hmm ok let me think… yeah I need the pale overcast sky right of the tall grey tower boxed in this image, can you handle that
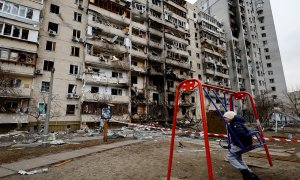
[187,0,300,90]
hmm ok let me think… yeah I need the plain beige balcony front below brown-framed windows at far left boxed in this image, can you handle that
[0,62,34,76]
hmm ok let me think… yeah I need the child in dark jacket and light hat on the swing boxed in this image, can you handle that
[223,111,259,180]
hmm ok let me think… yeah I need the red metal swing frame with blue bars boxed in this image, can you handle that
[167,79,272,180]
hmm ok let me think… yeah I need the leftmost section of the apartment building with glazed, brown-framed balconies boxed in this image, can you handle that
[0,0,43,132]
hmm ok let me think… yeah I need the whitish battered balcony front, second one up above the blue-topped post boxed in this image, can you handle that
[85,74,129,86]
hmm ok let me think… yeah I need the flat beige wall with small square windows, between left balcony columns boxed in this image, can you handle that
[31,0,87,125]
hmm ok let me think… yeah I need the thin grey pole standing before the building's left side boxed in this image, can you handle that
[43,68,55,146]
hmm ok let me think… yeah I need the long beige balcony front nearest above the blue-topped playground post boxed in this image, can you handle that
[83,93,129,103]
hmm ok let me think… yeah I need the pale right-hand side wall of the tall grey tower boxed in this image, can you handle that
[252,0,287,100]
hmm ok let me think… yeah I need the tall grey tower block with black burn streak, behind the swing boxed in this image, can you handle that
[195,0,286,101]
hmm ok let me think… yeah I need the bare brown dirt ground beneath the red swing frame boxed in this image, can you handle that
[4,138,300,180]
